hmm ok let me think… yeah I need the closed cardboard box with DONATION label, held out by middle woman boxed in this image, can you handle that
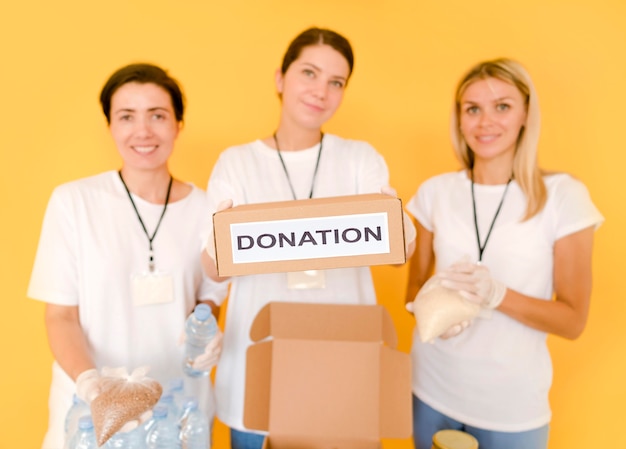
[213,194,406,276]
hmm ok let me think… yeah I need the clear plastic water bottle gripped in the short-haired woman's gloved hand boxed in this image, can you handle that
[183,304,217,377]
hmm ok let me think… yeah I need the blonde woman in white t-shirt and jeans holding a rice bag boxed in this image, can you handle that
[406,59,603,449]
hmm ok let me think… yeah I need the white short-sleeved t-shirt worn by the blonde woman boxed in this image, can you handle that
[407,171,603,432]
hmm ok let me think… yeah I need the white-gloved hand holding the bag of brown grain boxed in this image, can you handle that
[76,367,152,432]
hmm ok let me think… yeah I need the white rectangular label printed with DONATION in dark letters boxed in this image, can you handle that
[230,212,390,263]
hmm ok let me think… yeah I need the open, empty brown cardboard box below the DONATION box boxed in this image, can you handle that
[244,302,412,449]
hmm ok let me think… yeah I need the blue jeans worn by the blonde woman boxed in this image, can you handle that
[413,395,550,449]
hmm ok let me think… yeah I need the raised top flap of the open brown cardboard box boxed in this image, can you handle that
[250,302,398,348]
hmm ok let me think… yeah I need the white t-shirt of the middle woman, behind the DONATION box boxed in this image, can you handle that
[207,134,389,431]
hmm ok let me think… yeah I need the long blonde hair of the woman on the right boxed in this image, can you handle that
[450,58,547,220]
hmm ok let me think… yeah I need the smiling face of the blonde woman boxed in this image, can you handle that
[459,77,526,164]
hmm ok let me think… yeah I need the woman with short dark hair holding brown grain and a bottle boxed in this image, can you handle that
[28,64,219,449]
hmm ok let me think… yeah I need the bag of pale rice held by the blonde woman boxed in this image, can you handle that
[413,275,481,342]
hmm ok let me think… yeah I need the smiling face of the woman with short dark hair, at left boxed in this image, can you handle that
[109,82,180,171]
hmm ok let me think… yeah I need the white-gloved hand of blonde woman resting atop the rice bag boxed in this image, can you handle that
[437,260,506,309]
